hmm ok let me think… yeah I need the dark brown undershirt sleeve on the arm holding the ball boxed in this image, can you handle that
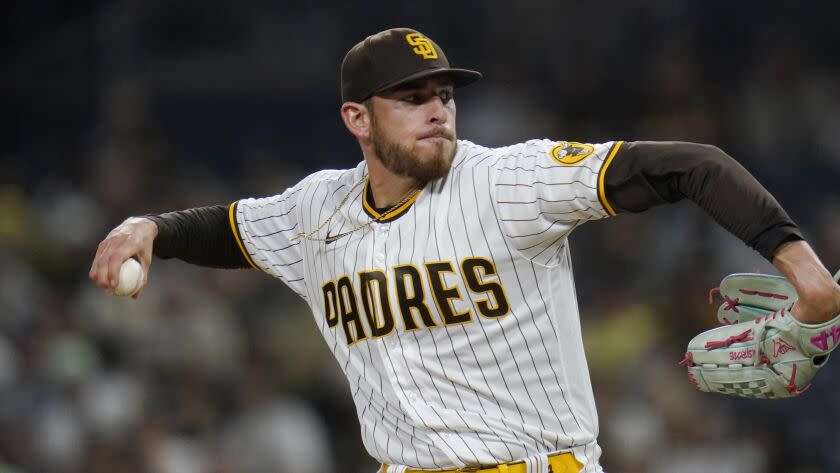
[146,205,250,268]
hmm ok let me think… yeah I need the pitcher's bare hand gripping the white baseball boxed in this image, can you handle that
[89,217,158,299]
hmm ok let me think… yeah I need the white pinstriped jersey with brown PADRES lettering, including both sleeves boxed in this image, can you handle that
[231,140,621,472]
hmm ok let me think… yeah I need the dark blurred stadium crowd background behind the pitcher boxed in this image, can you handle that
[0,0,840,473]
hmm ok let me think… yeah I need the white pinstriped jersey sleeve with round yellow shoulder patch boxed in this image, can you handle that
[494,140,622,265]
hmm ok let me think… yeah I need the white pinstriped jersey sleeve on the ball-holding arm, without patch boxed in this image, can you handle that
[229,182,306,299]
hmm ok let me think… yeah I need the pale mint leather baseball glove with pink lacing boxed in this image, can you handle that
[680,272,840,399]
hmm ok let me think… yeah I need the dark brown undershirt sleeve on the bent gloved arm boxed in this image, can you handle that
[604,141,804,262]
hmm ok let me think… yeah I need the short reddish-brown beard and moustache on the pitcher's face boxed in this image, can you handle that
[371,114,456,184]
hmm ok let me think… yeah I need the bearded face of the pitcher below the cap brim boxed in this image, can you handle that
[368,77,456,184]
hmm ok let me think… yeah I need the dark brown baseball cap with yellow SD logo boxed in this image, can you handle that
[341,28,481,102]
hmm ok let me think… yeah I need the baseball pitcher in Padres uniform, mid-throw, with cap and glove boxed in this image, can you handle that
[90,28,840,473]
